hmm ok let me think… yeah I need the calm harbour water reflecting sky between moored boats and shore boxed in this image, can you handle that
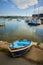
[0,19,43,42]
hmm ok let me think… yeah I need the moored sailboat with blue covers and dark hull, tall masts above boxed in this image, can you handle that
[27,2,41,26]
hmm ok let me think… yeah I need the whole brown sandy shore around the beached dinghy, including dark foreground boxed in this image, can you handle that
[0,41,43,65]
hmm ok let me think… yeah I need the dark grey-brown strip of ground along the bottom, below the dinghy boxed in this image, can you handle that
[0,52,43,65]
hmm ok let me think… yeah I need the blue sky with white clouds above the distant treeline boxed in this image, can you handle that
[0,0,43,16]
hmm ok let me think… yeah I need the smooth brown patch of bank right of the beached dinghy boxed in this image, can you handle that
[24,46,43,62]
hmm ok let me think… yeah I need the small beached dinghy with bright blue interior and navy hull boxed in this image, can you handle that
[9,39,31,57]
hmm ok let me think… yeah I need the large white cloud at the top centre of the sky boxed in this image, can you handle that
[11,0,38,9]
